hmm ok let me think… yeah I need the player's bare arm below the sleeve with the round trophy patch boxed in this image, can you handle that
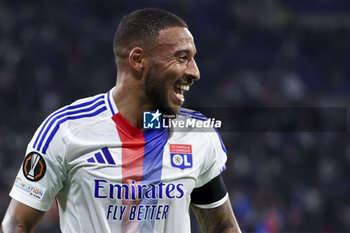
[0,199,45,233]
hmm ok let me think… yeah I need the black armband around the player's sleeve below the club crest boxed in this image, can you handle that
[191,174,227,205]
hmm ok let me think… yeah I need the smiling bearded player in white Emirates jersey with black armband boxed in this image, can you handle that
[0,9,240,233]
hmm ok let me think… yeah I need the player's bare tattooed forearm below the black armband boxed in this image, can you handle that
[191,199,241,233]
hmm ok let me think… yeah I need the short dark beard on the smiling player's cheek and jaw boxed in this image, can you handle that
[145,68,178,115]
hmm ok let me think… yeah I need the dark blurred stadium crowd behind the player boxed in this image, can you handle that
[0,0,350,233]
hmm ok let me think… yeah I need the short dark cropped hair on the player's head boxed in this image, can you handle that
[113,8,188,58]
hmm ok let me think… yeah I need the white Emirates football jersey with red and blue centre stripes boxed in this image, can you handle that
[10,91,227,233]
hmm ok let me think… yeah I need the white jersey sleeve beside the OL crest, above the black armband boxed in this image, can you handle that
[196,128,227,188]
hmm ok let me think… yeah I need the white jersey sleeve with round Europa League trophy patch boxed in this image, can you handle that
[10,118,66,211]
